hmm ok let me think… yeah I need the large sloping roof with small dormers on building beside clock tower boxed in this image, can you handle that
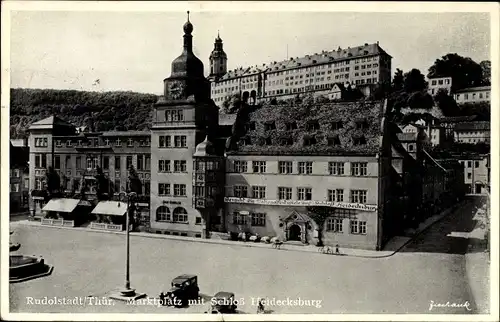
[226,101,384,155]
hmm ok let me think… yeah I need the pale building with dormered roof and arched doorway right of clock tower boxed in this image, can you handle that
[223,102,391,249]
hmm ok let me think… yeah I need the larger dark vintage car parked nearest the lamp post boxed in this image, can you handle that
[160,274,200,307]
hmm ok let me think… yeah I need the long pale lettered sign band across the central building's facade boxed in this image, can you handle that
[224,197,377,211]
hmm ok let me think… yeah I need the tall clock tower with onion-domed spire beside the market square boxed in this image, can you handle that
[150,11,219,237]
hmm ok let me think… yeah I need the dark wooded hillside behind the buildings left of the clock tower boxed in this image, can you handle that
[10,88,158,138]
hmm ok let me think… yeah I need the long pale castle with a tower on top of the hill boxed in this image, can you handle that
[209,36,392,106]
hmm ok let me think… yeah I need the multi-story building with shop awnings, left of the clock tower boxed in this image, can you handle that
[29,116,151,223]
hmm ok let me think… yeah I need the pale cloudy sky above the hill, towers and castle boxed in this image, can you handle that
[10,10,491,94]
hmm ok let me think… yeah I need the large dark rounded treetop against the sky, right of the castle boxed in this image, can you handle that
[427,54,483,92]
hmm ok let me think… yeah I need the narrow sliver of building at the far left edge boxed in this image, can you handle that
[9,140,29,213]
